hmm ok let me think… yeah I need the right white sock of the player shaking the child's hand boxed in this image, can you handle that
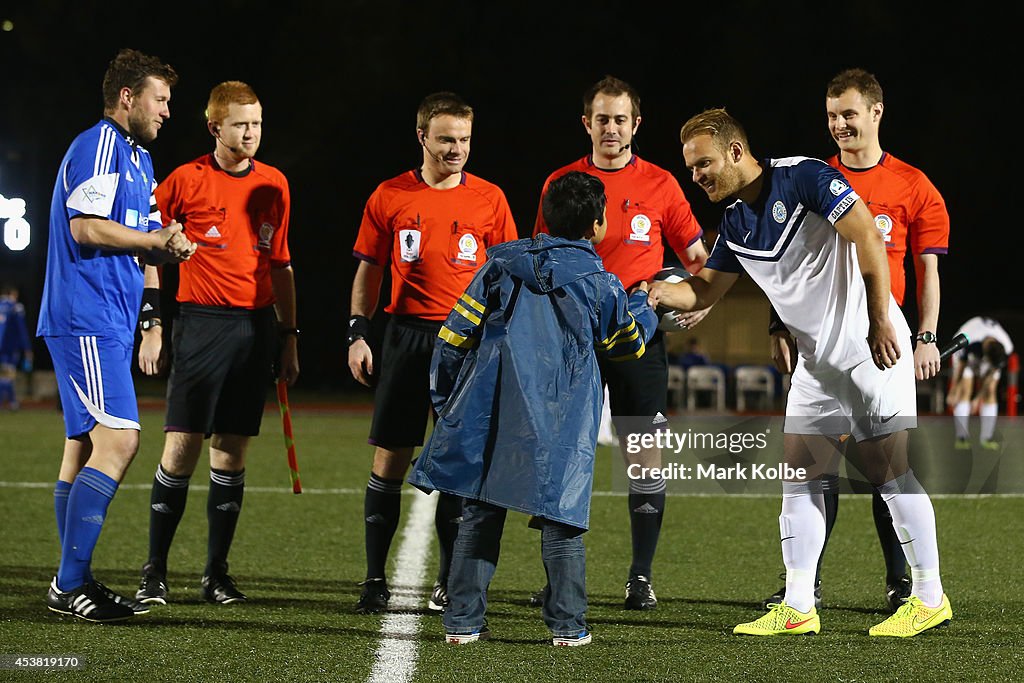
[879,470,942,607]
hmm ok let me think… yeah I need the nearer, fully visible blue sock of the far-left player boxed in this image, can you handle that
[57,467,118,591]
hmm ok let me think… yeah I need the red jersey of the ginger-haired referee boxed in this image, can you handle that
[156,155,291,308]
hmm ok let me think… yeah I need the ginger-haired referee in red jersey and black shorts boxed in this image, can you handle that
[135,81,299,604]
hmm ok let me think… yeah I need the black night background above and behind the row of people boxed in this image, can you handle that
[0,0,1024,390]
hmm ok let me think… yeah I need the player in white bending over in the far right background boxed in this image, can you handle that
[946,315,1014,451]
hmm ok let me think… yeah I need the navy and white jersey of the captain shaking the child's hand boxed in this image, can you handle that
[706,157,909,372]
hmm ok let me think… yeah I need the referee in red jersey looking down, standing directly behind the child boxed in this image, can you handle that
[530,76,708,609]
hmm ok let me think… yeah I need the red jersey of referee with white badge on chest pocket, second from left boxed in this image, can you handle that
[353,170,518,321]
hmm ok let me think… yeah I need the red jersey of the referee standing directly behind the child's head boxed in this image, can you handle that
[534,155,703,289]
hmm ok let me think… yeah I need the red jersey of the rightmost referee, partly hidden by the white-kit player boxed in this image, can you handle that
[828,153,949,306]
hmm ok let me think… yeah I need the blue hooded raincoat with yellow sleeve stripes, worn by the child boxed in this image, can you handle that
[409,234,657,528]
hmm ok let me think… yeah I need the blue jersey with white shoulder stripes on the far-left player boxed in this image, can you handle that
[36,119,162,339]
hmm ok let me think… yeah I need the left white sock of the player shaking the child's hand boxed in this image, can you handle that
[778,481,825,612]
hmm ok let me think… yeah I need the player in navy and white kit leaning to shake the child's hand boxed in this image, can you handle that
[651,109,952,637]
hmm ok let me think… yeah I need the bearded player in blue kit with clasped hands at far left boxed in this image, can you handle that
[37,49,196,622]
